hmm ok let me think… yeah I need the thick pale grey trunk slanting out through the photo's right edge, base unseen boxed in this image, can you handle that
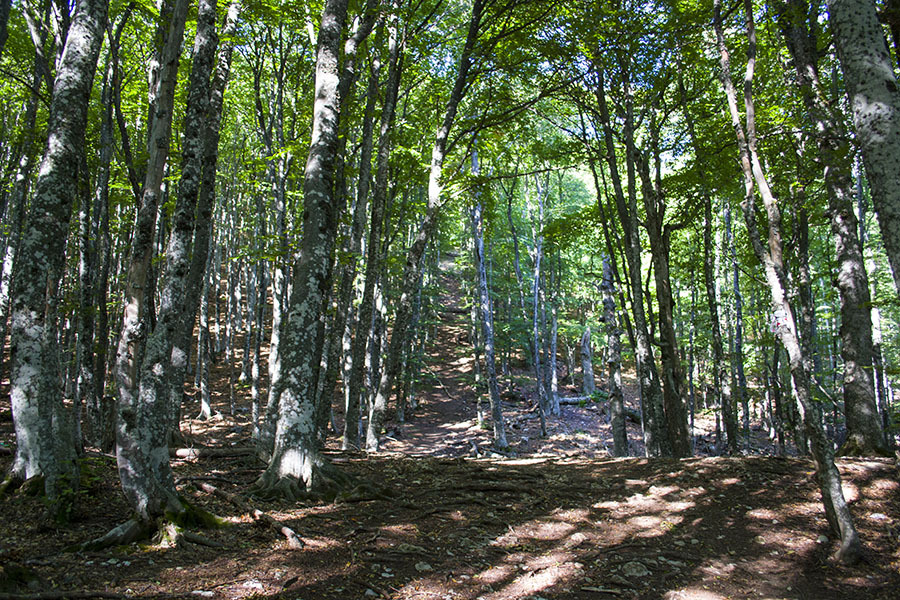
[827,0,900,294]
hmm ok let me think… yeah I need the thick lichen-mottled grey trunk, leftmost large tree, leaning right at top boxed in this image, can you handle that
[2,0,108,518]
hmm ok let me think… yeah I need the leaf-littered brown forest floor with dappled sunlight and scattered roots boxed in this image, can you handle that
[0,264,900,600]
